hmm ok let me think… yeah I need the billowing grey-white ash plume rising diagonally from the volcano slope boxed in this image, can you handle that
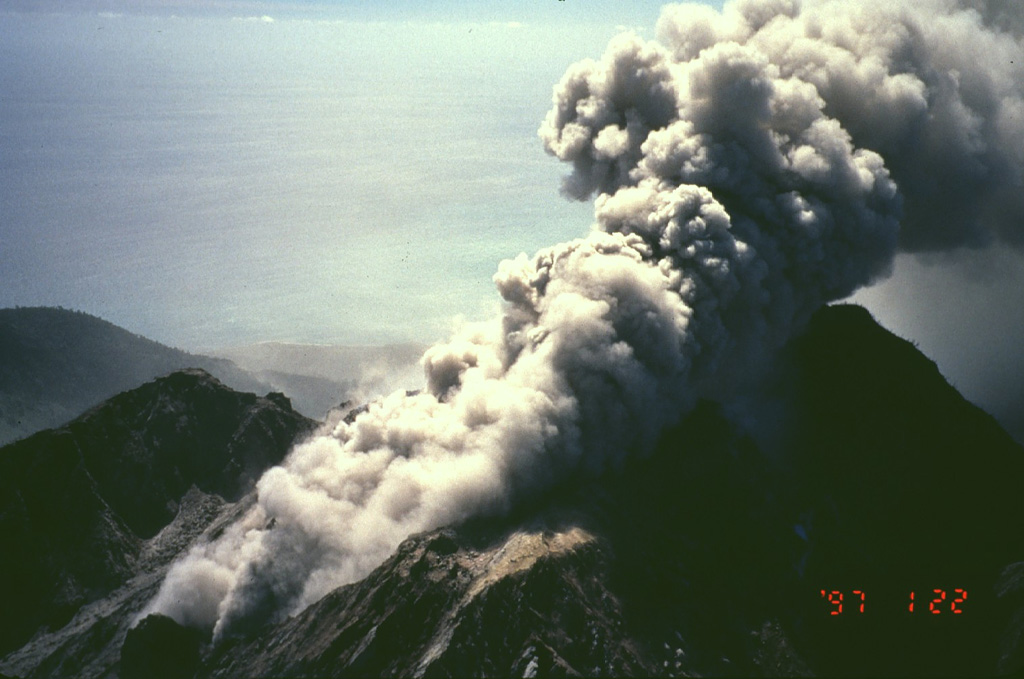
[150,0,1024,637]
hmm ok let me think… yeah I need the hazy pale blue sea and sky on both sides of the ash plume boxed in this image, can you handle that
[0,0,1024,440]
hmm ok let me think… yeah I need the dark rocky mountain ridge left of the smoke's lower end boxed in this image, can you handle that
[0,371,313,653]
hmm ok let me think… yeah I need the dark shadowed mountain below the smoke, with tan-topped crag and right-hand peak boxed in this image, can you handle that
[190,306,1024,677]
